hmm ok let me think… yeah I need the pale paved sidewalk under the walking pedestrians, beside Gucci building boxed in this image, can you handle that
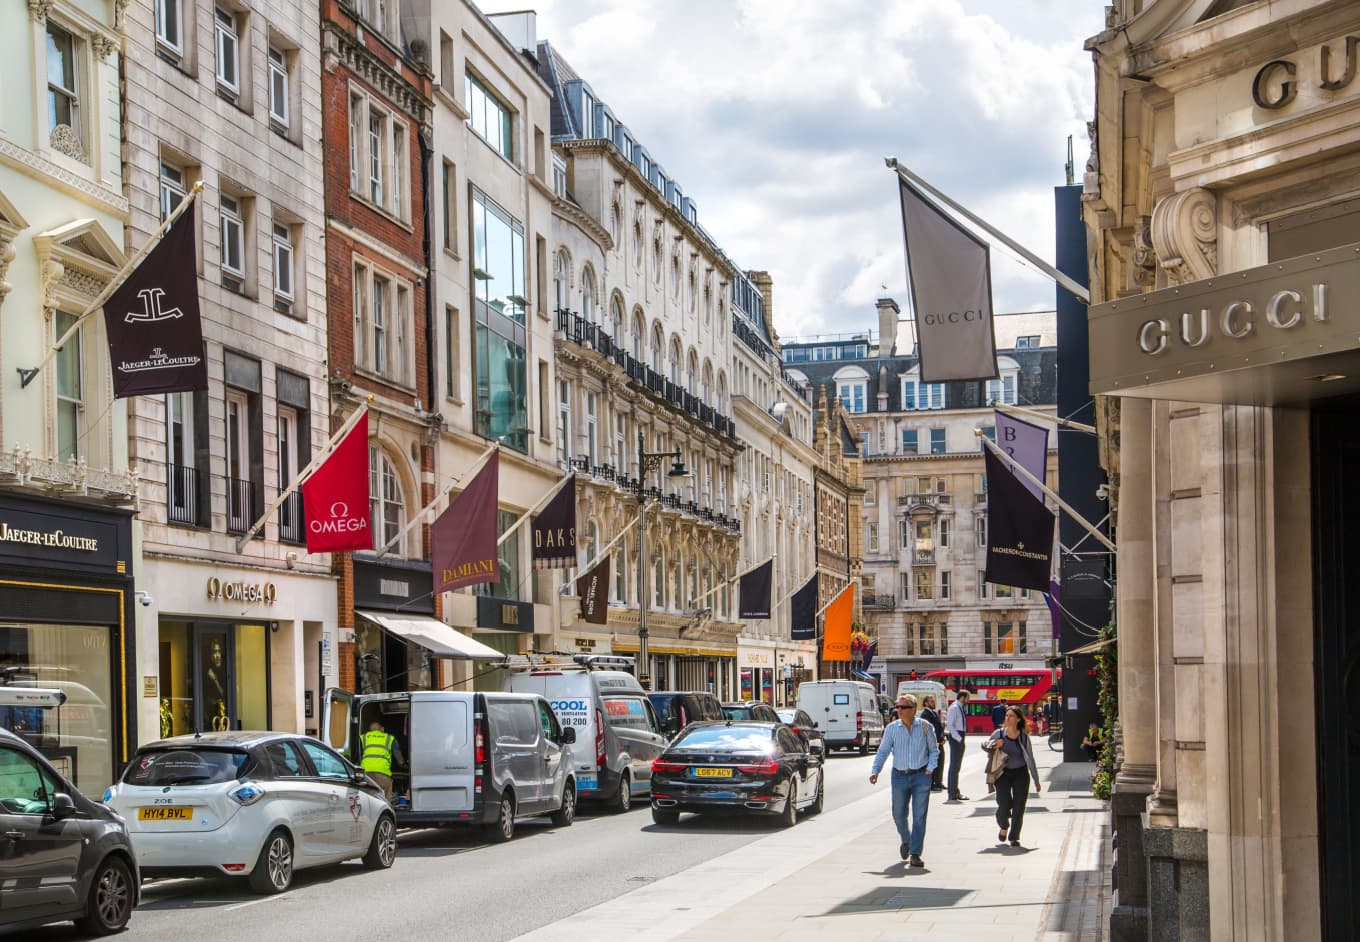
[520,737,1108,942]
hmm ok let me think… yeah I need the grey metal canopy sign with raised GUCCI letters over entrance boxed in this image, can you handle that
[1088,242,1360,405]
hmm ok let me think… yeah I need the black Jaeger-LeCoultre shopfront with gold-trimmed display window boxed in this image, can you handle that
[0,493,137,795]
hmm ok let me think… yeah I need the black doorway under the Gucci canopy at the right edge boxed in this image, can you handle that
[1312,398,1360,942]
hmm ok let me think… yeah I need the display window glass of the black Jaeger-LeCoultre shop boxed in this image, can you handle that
[0,623,117,795]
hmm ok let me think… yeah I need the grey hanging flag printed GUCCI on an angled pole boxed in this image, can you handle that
[899,177,997,383]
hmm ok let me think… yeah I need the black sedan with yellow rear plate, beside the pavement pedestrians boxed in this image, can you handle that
[651,720,826,828]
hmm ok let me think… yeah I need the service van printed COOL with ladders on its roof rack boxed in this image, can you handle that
[505,654,666,813]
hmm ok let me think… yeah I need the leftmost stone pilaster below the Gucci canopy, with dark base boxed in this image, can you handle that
[1110,398,1157,942]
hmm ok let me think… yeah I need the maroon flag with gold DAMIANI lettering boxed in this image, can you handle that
[430,451,500,593]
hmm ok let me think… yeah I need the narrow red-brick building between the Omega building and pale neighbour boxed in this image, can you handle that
[321,0,439,692]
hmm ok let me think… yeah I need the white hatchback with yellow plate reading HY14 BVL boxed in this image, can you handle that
[103,733,397,893]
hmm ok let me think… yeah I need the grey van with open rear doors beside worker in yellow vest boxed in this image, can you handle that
[322,688,577,841]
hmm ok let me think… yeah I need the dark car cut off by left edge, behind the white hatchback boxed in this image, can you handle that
[0,729,141,935]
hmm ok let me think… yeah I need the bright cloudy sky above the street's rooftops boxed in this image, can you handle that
[479,0,1104,340]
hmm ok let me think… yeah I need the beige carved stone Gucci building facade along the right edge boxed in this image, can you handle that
[1084,0,1360,939]
